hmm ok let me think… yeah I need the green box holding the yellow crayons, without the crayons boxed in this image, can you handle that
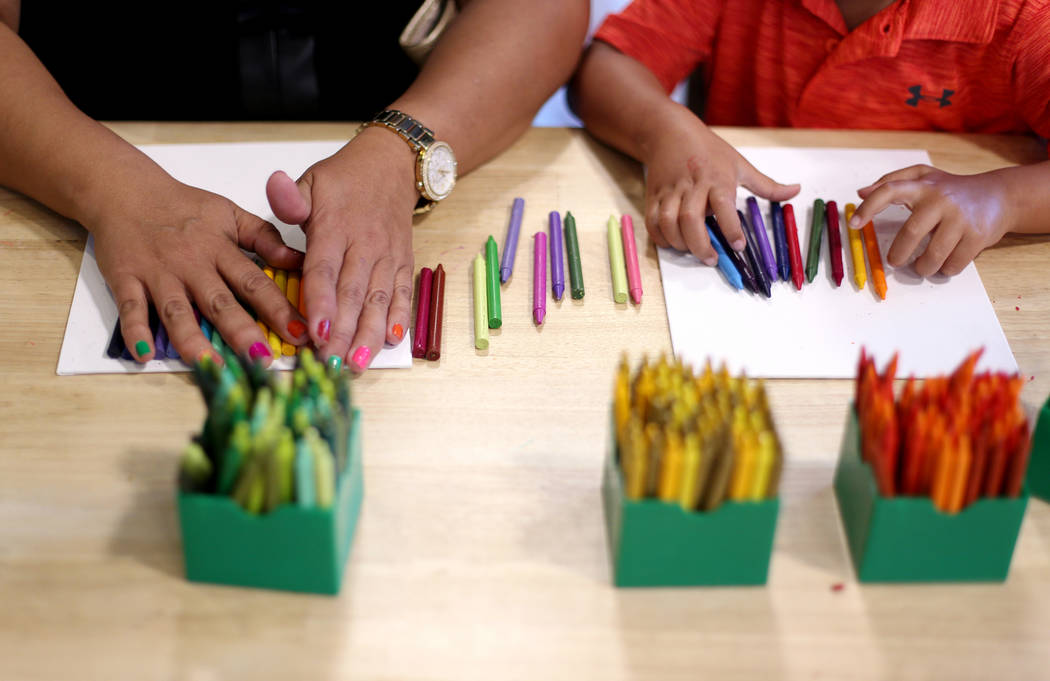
[602,419,780,587]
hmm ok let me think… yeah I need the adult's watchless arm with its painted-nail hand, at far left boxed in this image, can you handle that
[0,19,306,361]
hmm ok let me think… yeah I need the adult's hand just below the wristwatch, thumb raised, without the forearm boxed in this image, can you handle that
[267,128,419,371]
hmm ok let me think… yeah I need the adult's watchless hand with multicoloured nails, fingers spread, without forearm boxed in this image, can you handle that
[90,180,308,364]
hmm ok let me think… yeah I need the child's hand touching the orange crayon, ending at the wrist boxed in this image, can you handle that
[849,165,1013,277]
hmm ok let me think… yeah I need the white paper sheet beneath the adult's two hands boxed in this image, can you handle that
[58,142,412,376]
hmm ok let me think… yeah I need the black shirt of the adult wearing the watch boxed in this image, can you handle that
[19,0,419,121]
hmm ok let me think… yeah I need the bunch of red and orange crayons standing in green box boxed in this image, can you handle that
[856,350,1031,513]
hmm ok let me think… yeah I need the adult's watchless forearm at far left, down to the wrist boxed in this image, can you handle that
[0,24,170,227]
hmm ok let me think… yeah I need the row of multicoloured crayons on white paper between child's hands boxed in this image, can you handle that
[707,196,886,300]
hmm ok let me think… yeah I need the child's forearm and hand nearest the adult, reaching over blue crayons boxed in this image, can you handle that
[572,42,799,265]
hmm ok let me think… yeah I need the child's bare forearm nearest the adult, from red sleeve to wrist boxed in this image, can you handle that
[570,42,696,163]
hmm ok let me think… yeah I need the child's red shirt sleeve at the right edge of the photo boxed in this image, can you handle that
[1011,2,1050,151]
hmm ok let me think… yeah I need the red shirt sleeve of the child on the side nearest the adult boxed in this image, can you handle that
[594,0,725,93]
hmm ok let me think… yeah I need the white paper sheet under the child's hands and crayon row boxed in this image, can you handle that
[659,147,1017,378]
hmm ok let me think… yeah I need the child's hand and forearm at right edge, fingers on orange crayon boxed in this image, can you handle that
[849,162,1050,277]
